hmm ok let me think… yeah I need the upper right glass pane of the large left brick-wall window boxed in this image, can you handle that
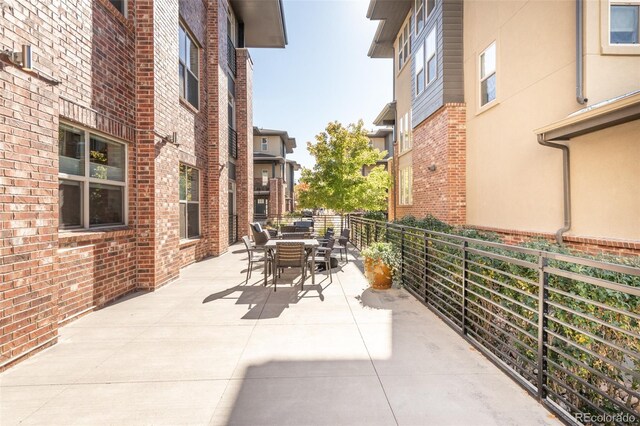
[89,135,126,182]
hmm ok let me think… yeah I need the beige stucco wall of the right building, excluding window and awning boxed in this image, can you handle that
[464,0,640,239]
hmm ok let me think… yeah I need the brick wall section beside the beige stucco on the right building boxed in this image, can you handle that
[394,104,466,224]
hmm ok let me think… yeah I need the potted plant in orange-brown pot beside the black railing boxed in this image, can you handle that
[362,243,400,290]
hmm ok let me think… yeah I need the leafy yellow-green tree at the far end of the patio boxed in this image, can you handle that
[298,120,391,214]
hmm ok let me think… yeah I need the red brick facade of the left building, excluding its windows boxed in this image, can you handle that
[0,0,253,370]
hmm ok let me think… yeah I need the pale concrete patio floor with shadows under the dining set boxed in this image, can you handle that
[0,245,560,425]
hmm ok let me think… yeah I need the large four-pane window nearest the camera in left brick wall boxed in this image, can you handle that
[58,125,127,229]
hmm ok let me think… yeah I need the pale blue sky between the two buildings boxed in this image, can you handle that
[251,0,393,167]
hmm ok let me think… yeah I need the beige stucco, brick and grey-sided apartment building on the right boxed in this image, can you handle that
[368,0,640,254]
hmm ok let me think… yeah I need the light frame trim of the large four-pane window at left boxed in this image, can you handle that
[58,120,129,232]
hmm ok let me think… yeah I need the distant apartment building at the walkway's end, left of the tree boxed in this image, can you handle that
[253,127,300,221]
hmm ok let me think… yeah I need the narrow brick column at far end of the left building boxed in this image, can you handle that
[236,49,253,237]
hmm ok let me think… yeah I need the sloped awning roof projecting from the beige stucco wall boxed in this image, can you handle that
[535,90,640,141]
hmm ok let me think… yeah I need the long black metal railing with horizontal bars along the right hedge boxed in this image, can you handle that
[349,216,640,425]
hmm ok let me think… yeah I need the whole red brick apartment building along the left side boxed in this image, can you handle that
[0,0,287,369]
